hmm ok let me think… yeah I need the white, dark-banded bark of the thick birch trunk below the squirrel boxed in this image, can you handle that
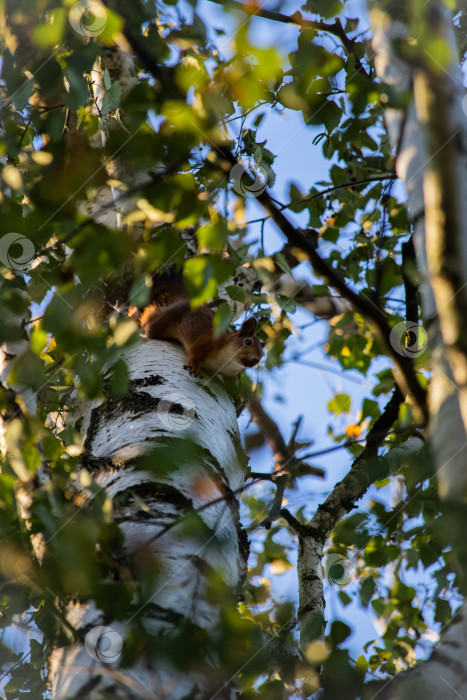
[50,340,247,700]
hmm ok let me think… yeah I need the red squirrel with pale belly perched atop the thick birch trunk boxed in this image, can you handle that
[140,276,263,377]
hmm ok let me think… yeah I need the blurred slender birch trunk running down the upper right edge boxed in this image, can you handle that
[371,2,467,499]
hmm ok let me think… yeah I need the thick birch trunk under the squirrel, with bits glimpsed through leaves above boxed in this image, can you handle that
[44,42,248,700]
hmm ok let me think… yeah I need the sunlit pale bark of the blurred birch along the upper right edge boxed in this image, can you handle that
[371,3,467,499]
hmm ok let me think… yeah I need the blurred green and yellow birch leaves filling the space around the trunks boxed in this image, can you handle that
[0,0,466,700]
